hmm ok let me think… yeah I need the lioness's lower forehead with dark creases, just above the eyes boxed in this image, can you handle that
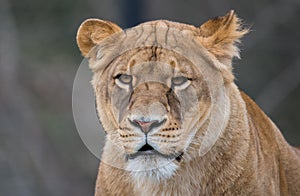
[114,47,196,79]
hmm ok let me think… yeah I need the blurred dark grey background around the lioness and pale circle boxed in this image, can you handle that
[0,0,300,196]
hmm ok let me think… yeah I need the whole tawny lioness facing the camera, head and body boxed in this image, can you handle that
[77,11,300,196]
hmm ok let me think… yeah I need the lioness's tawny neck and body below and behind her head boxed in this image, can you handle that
[96,86,300,196]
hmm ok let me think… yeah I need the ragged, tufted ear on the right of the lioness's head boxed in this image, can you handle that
[199,10,248,65]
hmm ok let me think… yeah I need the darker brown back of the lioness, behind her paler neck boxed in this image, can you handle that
[241,91,300,193]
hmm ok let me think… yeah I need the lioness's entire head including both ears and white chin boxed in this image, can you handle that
[77,12,247,180]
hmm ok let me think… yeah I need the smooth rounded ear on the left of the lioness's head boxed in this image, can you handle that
[76,19,122,57]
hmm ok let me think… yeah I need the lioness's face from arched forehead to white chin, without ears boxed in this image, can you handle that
[93,48,211,179]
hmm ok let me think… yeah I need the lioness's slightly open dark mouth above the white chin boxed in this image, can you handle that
[127,143,183,162]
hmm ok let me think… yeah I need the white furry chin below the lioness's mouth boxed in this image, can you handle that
[126,154,178,185]
